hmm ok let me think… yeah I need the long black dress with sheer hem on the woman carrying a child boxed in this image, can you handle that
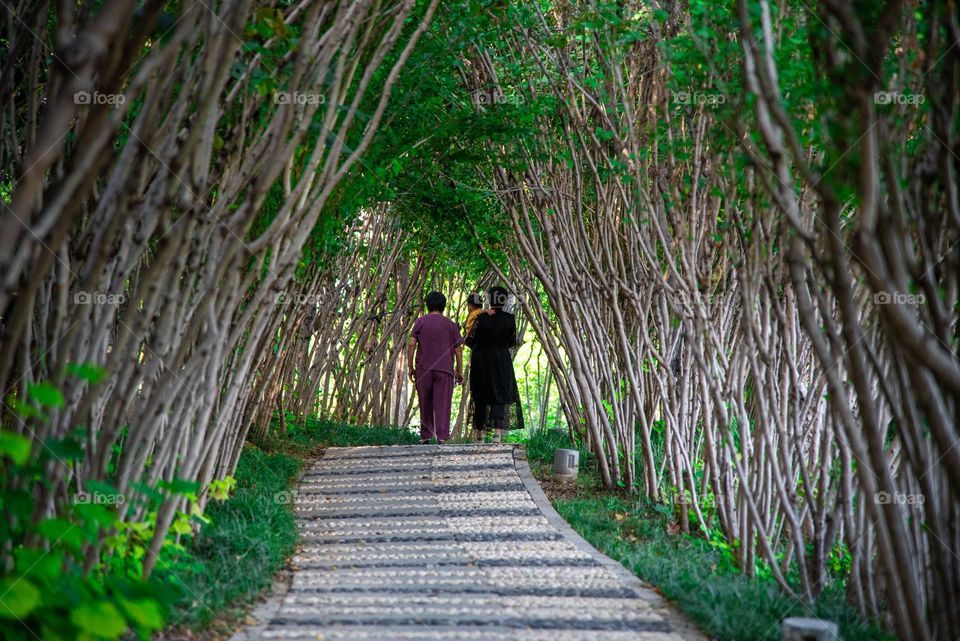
[466,310,523,430]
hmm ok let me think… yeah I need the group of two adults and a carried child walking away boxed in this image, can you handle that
[407,287,523,443]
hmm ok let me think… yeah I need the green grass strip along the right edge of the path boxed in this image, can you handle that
[527,433,893,641]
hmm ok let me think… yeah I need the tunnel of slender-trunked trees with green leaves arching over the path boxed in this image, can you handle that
[0,0,960,641]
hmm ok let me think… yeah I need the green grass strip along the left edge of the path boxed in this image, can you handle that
[159,419,417,641]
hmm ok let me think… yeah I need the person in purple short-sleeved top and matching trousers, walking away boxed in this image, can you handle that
[407,292,463,445]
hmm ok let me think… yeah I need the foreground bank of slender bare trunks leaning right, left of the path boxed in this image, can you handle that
[0,0,436,573]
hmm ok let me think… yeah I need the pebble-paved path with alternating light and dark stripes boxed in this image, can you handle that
[232,445,704,641]
